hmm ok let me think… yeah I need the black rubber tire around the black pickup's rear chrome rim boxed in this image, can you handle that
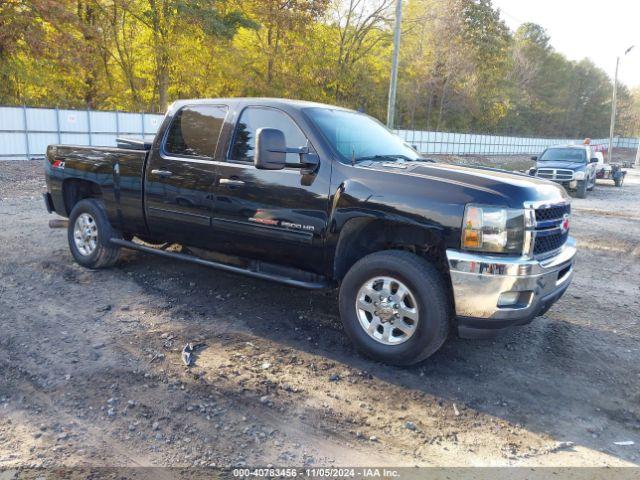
[67,199,121,269]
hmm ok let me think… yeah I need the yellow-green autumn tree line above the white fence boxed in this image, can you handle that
[0,0,640,137]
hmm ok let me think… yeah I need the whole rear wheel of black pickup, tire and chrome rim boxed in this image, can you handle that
[67,199,121,268]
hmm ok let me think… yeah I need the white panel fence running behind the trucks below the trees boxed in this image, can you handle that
[0,107,638,160]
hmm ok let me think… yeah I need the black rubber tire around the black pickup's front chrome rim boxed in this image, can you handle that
[340,250,450,365]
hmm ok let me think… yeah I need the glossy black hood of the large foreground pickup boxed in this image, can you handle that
[361,162,568,208]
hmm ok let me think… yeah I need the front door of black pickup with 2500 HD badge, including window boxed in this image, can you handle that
[212,106,331,273]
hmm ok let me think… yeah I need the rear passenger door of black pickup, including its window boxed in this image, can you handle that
[145,104,228,244]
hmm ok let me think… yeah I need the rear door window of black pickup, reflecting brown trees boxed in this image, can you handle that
[164,105,227,159]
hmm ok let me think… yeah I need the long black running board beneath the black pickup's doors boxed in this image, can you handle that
[111,238,330,290]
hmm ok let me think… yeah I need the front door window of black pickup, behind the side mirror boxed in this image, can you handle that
[230,107,307,163]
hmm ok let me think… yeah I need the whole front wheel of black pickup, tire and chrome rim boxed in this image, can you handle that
[340,250,450,365]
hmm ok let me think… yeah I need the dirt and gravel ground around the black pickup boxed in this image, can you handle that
[0,158,640,467]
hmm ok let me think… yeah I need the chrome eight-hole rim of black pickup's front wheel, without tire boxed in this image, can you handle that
[356,277,418,345]
